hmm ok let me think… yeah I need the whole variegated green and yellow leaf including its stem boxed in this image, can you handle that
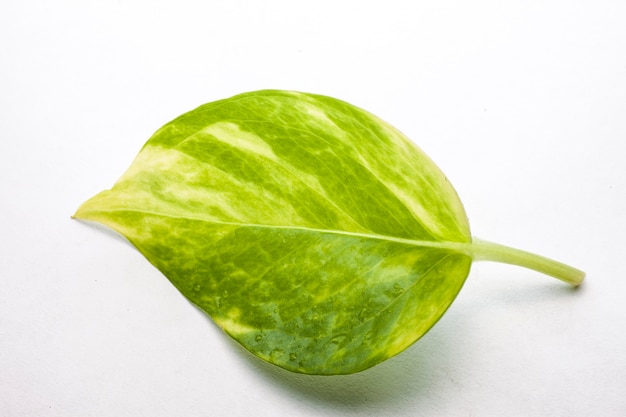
[74,91,584,374]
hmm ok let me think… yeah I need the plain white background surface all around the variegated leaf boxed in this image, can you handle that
[0,0,626,417]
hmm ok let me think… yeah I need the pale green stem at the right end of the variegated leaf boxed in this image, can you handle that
[471,238,585,286]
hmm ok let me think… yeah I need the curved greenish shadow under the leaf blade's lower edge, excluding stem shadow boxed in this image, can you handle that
[214,308,460,412]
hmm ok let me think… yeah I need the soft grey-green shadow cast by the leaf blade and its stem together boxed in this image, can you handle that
[212,274,584,413]
